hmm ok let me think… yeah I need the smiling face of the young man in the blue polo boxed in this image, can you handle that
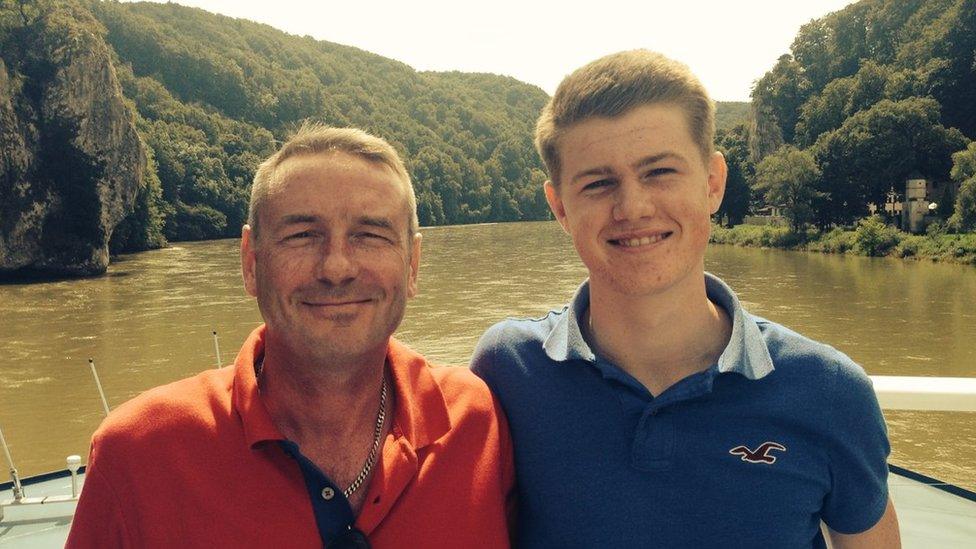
[546,104,726,297]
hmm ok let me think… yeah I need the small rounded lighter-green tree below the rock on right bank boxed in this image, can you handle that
[756,145,824,233]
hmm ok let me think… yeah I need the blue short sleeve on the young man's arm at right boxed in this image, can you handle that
[822,357,891,534]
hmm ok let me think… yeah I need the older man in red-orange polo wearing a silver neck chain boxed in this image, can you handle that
[68,127,513,547]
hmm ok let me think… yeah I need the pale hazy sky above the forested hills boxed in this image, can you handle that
[127,0,851,101]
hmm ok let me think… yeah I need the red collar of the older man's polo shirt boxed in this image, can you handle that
[231,325,451,449]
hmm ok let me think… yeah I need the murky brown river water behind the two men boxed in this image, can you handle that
[0,222,976,489]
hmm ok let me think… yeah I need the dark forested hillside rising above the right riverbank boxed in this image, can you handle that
[740,0,976,230]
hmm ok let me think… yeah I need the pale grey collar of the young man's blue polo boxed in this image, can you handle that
[542,273,773,380]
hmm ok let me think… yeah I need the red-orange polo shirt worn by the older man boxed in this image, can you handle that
[67,326,514,549]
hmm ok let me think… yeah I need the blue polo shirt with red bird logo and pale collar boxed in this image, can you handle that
[472,274,889,547]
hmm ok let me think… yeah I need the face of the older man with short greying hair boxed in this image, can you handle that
[242,152,420,361]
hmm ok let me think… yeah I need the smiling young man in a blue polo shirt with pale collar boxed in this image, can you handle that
[472,51,899,547]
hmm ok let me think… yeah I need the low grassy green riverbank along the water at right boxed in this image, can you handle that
[710,220,976,266]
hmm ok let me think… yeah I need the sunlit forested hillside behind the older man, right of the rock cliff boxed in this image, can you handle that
[87,2,560,248]
